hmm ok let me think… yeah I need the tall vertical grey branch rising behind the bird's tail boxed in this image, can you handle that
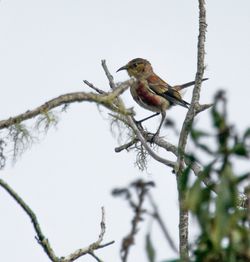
[176,0,207,261]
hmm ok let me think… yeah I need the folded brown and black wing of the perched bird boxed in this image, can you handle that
[147,75,189,108]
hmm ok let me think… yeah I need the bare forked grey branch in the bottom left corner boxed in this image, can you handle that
[0,179,114,262]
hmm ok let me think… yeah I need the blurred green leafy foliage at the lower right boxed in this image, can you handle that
[184,91,250,262]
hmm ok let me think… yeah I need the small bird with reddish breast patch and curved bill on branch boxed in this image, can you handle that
[117,58,208,136]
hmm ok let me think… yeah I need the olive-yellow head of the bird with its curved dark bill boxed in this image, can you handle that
[116,58,152,78]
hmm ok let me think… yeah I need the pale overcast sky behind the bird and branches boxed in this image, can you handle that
[0,0,250,262]
